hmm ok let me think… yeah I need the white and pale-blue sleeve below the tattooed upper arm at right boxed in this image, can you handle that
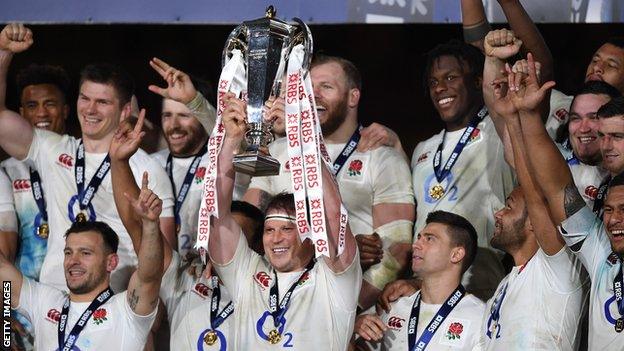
[559,206,611,280]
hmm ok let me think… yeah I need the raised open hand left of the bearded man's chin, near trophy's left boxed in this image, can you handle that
[108,109,145,161]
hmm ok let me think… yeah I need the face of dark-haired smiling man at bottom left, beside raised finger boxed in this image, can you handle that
[63,231,115,294]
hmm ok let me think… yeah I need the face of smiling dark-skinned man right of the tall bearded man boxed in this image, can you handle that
[428,56,481,130]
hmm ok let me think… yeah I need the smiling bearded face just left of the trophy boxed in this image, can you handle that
[162,99,208,157]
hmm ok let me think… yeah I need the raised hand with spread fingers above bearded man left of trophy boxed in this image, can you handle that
[147,57,197,104]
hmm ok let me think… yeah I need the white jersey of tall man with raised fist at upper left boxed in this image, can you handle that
[28,129,173,291]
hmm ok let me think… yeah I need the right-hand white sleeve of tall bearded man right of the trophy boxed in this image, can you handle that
[373,147,414,205]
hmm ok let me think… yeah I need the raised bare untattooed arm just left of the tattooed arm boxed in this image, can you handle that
[496,60,565,255]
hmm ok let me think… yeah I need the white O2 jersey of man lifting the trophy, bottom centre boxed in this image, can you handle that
[215,233,362,351]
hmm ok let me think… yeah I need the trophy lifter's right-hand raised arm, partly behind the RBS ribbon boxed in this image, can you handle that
[322,162,357,273]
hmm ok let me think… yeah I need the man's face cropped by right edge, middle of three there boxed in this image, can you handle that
[598,116,624,175]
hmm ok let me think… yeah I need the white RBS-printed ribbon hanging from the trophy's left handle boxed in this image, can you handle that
[195,50,247,264]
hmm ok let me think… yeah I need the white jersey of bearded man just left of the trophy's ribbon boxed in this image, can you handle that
[150,149,249,258]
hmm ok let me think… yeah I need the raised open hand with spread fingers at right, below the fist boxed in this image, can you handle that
[506,53,555,112]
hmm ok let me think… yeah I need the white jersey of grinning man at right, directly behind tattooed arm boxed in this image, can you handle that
[557,144,609,208]
